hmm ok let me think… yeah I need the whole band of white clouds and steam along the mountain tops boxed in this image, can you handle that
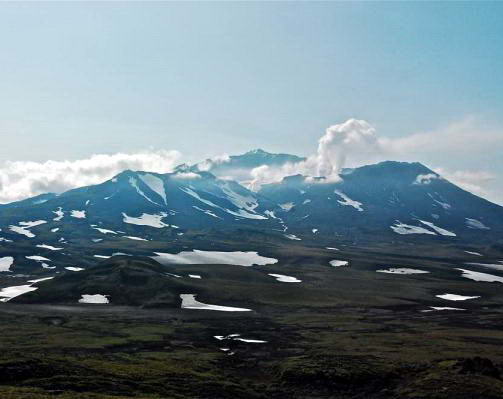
[0,117,503,204]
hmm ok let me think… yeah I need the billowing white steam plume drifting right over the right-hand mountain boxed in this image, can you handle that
[250,117,503,203]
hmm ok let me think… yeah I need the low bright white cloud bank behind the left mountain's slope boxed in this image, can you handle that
[0,150,180,203]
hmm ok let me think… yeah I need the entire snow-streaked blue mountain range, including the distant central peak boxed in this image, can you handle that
[0,154,503,256]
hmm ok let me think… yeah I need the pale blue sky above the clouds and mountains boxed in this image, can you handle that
[0,2,503,202]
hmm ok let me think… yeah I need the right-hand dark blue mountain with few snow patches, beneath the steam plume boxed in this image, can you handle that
[259,161,503,240]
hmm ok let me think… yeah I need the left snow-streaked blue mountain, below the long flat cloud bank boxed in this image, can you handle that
[0,170,284,238]
